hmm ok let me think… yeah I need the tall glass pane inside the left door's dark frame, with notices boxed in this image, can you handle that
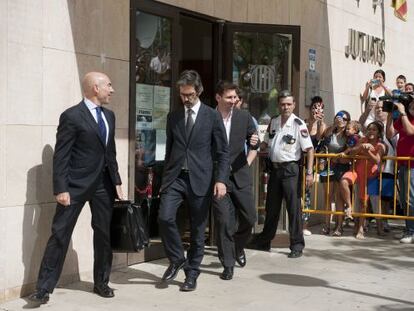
[134,10,172,239]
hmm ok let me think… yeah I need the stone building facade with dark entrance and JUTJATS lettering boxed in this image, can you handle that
[0,0,414,302]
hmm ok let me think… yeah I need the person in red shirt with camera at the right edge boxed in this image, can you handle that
[387,98,414,244]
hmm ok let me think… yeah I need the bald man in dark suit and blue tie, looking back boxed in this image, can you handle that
[29,72,123,303]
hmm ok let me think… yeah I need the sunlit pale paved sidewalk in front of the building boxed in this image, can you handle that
[0,230,414,311]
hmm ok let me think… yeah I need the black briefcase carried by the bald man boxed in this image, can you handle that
[111,201,149,252]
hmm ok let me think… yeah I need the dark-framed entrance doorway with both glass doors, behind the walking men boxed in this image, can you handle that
[128,0,300,264]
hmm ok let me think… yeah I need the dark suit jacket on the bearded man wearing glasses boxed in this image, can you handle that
[161,103,229,196]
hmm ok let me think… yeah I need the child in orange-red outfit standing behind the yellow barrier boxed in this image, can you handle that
[340,121,386,239]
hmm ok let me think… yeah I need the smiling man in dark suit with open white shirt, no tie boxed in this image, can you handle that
[213,81,259,280]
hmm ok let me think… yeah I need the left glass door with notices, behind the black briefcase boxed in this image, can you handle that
[128,1,177,264]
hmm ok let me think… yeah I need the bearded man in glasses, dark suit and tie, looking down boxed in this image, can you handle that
[158,70,229,291]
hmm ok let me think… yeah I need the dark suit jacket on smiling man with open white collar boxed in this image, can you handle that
[229,109,259,188]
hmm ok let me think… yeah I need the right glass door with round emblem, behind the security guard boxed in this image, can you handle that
[223,23,300,232]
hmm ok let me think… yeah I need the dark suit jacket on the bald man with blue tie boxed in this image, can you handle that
[53,101,121,202]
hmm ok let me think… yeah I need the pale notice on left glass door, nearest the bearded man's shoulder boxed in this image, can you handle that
[153,85,171,130]
